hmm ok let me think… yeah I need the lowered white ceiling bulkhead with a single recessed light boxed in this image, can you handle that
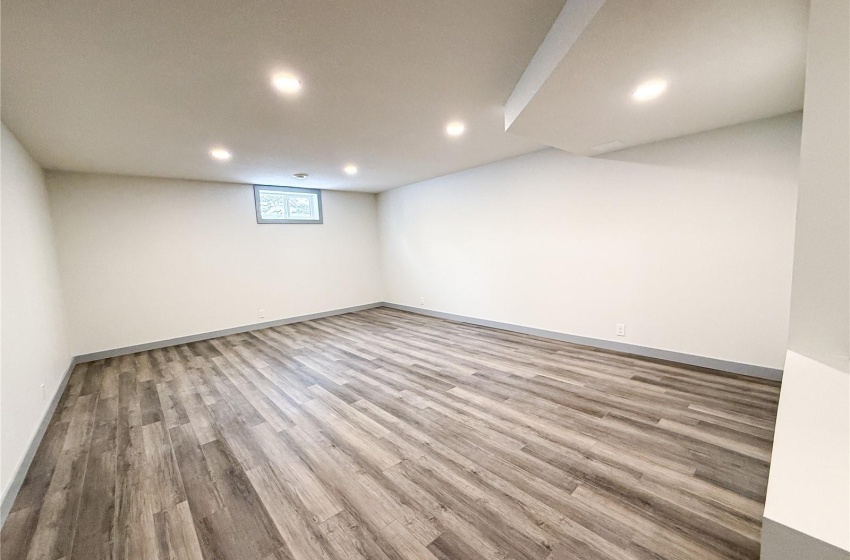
[507,0,808,155]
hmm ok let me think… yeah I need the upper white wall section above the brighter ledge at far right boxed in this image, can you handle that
[788,0,850,364]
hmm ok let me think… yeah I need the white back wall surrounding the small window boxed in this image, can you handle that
[48,172,381,355]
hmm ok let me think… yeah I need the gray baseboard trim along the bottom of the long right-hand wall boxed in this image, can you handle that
[382,301,782,381]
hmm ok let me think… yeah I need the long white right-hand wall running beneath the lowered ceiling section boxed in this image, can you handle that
[379,113,801,369]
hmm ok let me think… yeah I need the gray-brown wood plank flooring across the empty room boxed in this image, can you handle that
[0,308,779,560]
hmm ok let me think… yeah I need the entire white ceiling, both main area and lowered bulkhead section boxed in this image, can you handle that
[2,0,808,192]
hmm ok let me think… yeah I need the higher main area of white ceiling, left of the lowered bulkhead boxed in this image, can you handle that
[2,0,564,191]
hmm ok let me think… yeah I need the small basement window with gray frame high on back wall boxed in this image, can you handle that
[254,185,322,224]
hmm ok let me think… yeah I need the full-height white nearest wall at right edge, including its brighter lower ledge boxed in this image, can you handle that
[762,0,850,560]
